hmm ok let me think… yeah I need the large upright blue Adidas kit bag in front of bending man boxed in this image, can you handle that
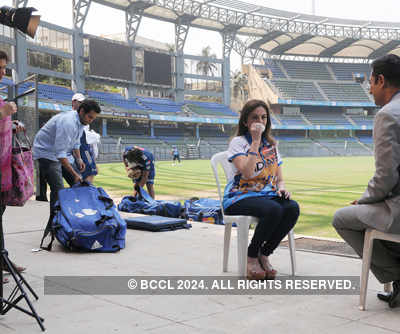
[40,182,126,252]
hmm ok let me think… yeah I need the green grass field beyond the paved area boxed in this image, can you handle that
[95,157,374,237]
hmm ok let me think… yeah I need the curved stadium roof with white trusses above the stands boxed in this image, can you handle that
[93,0,400,59]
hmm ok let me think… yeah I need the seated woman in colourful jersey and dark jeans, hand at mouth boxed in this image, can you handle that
[223,100,300,279]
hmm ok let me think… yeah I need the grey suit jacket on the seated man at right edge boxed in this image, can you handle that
[358,93,400,233]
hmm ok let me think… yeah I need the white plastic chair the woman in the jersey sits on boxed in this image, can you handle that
[211,151,296,277]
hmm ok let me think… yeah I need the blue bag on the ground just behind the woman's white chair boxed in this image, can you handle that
[185,197,224,225]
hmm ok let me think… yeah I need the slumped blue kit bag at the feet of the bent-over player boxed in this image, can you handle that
[118,188,182,218]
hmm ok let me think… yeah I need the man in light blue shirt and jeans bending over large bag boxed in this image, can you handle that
[33,100,101,220]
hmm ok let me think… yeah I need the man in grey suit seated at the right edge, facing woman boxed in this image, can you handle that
[333,54,400,307]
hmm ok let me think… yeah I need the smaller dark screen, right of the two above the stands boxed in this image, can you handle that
[144,51,172,86]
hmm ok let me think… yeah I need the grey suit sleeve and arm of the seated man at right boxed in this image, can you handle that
[357,111,400,204]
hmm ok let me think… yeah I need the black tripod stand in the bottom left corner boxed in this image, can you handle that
[0,217,45,331]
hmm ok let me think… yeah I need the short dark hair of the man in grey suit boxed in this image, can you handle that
[371,54,400,88]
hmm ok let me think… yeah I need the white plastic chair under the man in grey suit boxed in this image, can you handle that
[359,229,400,311]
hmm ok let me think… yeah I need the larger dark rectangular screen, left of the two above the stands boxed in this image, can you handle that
[89,38,132,81]
